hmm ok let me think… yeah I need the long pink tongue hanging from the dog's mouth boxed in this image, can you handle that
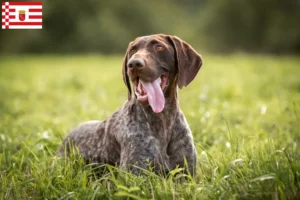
[141,78,165,113]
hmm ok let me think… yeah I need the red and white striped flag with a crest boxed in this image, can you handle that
[2,1,43,29]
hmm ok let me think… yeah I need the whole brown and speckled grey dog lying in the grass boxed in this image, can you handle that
[60,34,202,174]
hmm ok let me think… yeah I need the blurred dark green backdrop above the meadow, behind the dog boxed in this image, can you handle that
[0,0,300,55]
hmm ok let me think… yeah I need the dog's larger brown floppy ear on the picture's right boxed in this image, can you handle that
[169,36,202,89]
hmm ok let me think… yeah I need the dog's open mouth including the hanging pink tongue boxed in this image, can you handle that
[133,75,168,113]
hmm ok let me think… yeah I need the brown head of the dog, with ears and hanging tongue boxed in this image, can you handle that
[122,34,202,113]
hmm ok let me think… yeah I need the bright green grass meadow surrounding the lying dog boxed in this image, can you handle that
[0,55,300,199]
